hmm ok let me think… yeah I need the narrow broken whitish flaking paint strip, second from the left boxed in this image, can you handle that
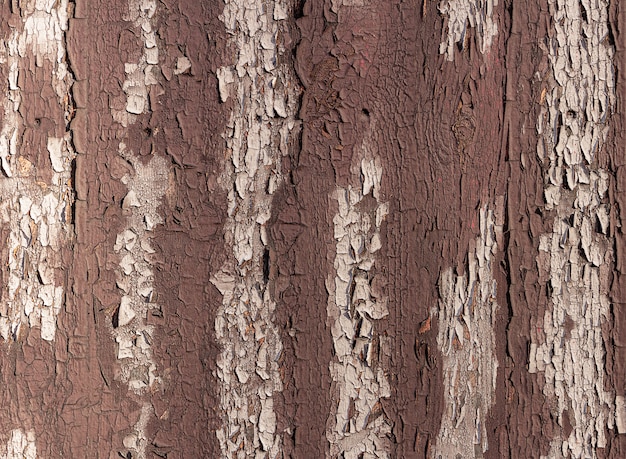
[111,0,165,459]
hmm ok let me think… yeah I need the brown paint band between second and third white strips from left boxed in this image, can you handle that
[137,1,231,458]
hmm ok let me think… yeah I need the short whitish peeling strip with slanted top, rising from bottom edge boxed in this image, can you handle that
[434,205,504,458]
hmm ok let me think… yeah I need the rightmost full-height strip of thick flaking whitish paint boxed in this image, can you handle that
[528,0,620,458]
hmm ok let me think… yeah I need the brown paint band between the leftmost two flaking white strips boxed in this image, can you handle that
[62,1,139,457]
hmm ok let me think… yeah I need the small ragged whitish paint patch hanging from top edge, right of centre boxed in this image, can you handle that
[439,0,498,61]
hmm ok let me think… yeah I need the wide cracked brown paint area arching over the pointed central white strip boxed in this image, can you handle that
[274,2,504,457]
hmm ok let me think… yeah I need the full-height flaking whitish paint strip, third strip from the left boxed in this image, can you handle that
[210,0,298,458]
